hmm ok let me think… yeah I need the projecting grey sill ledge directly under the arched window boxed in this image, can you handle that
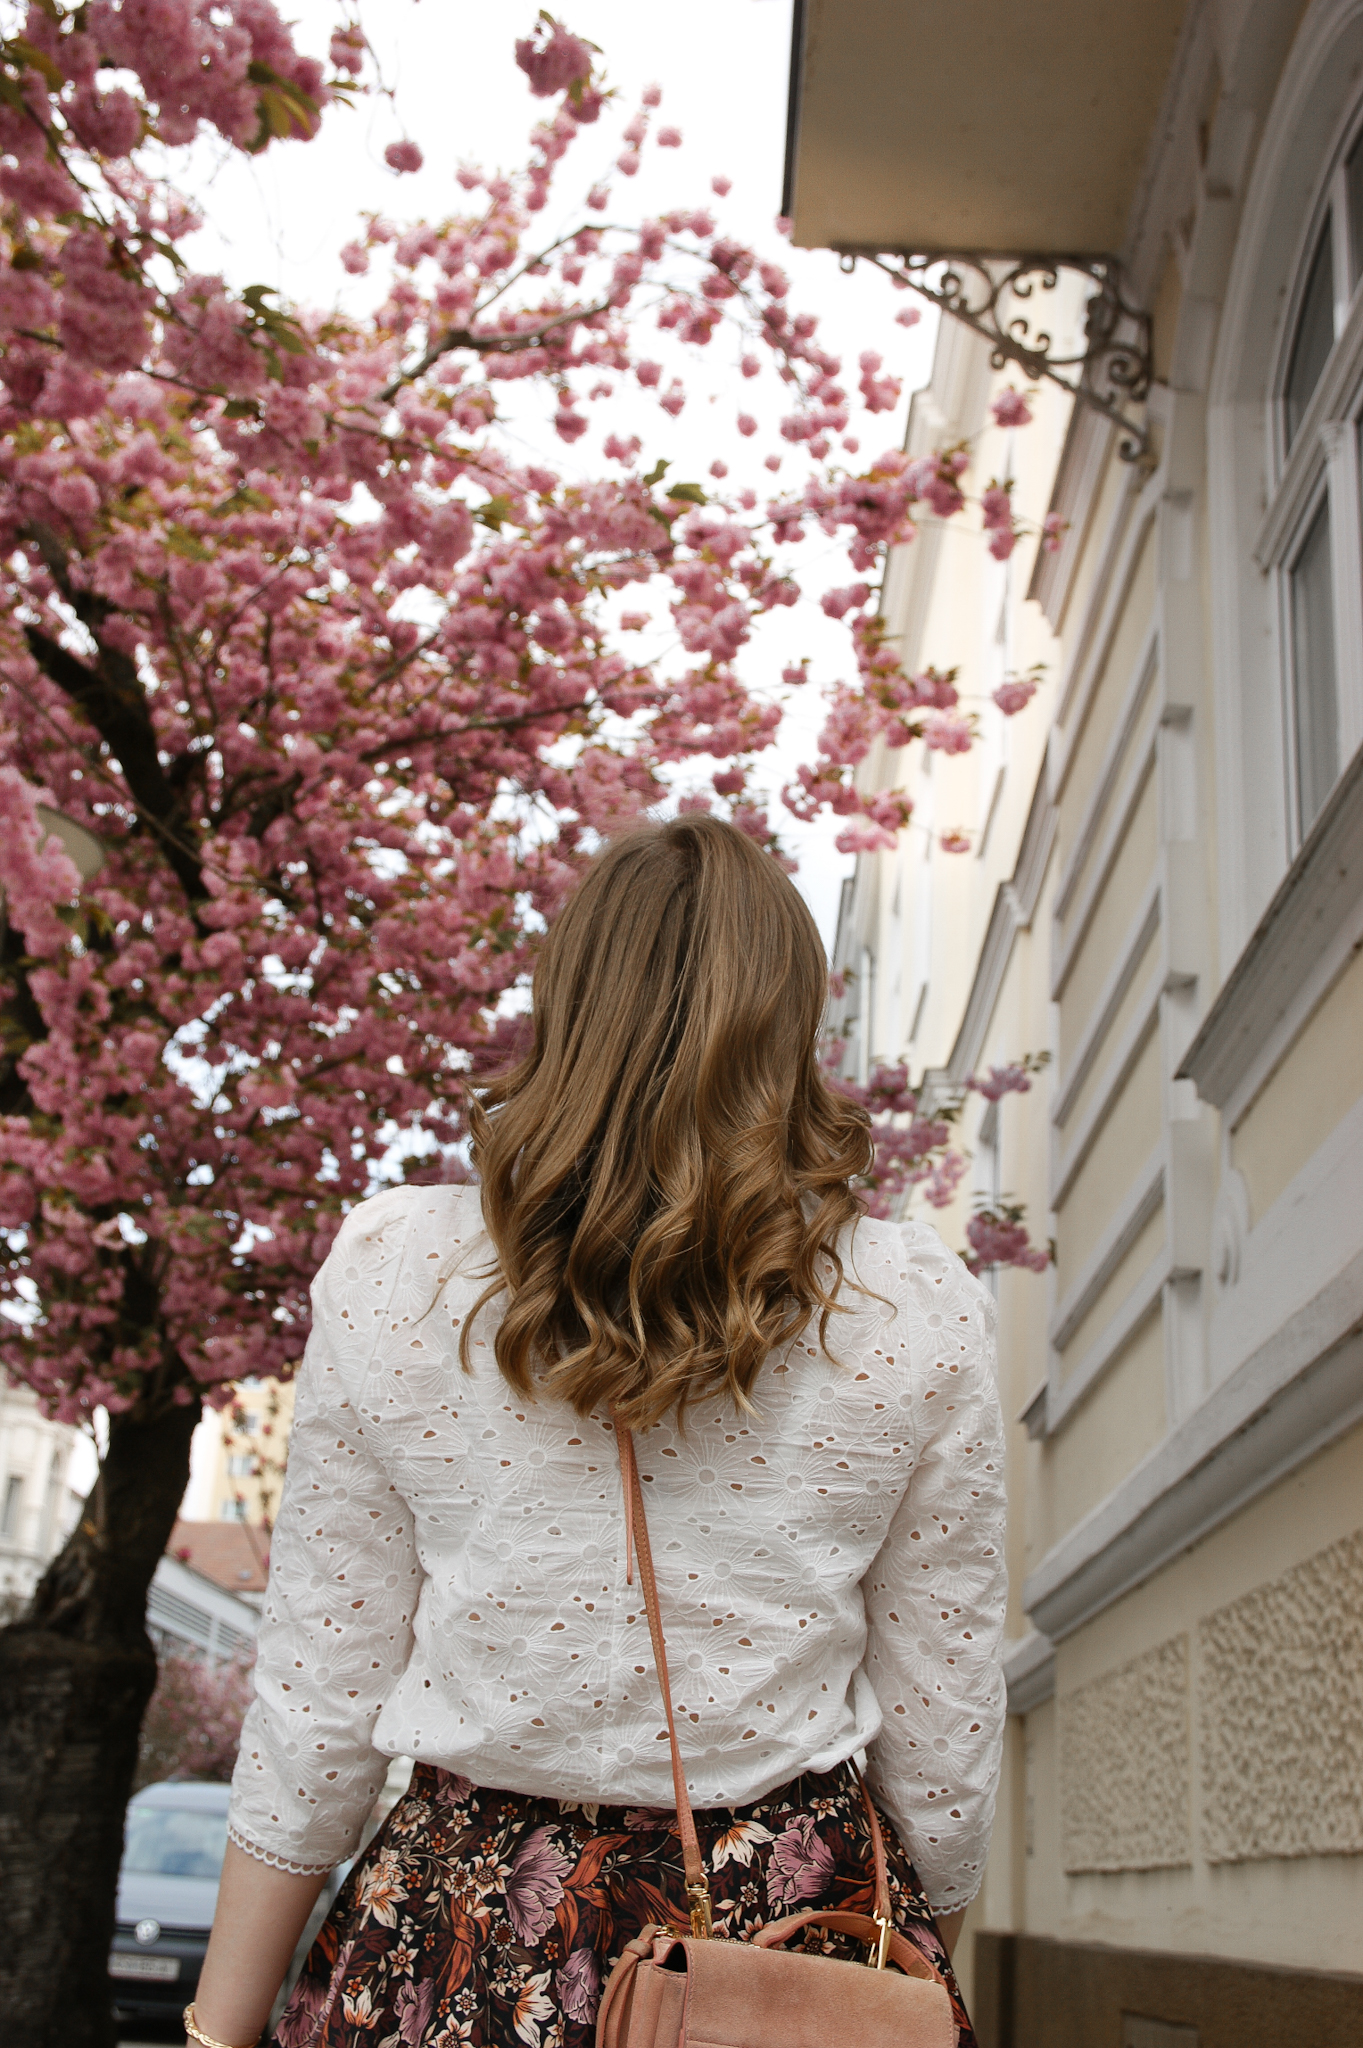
[1177,750,1363,1110]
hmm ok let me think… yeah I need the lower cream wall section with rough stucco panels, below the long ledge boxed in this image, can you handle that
[1031,1430,1363,1970]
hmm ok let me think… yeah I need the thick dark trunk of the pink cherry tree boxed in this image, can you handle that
[0,1401,199,2048]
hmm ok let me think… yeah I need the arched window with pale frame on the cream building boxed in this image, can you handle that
[1257,117,1363,846]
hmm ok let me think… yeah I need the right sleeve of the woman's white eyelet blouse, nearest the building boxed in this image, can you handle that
[862,1225,1007,1913]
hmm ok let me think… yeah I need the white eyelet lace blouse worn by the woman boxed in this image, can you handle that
[231,1188,1005,1913]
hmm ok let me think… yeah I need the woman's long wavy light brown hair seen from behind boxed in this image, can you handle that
[460,815,872,1423]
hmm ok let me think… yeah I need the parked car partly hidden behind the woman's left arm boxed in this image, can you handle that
[108,1780,231,2019]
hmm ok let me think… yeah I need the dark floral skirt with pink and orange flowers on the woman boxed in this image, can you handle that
[274,1763,974,2048]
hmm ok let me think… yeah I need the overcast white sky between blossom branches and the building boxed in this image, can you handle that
[169,0,935,942]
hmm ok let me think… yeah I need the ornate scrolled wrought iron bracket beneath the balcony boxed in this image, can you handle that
[843,250,1154,463]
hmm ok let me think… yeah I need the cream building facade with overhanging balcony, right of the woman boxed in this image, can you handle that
[786,0,1363,2048]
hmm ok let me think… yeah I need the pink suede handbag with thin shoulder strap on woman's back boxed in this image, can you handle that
[596,1423,956,2048]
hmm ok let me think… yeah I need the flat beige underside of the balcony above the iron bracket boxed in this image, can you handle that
[786,0,1191,256]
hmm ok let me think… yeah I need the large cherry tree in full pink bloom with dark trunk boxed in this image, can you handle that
[0,16,1031,2044]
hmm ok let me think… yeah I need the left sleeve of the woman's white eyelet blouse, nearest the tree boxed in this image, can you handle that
[229,1190,420,1874]
